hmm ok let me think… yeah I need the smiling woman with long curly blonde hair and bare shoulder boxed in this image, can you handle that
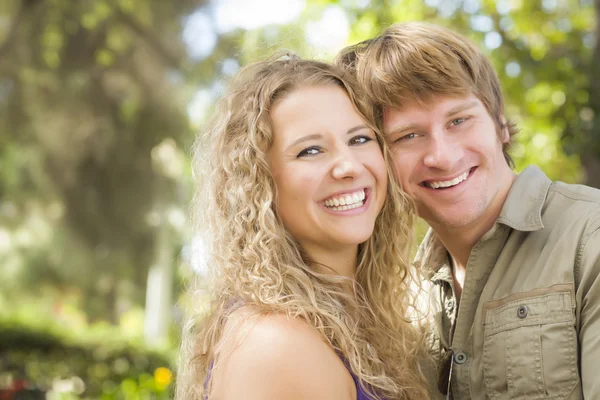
[177,57,428,400]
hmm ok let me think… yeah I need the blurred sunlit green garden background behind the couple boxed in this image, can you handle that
[0,0,600,399]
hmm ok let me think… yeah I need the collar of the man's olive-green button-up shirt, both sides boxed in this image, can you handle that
[414,166,552,280]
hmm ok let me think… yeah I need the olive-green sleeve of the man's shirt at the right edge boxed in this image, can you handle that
[575,226,600,399]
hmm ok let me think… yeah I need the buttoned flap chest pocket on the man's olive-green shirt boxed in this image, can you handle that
[483,284,579,399]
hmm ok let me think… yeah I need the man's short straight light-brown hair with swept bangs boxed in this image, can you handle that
[336,22,517,167]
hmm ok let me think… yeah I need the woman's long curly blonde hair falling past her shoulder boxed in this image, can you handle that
[176,56,429,399]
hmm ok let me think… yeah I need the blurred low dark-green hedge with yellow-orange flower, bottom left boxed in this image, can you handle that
[0,319,173,399]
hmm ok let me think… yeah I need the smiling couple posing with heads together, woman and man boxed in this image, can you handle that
[177,23,600,400]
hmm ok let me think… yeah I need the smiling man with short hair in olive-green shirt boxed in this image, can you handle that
[337,23,600,399]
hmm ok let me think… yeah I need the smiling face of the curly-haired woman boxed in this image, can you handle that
[269,84,387,254]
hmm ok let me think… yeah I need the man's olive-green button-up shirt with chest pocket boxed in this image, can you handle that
[415,167,600,400]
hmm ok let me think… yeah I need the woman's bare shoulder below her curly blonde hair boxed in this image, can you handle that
[211,306,356,400]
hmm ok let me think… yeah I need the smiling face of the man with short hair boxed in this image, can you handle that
[383,95,514,230]
